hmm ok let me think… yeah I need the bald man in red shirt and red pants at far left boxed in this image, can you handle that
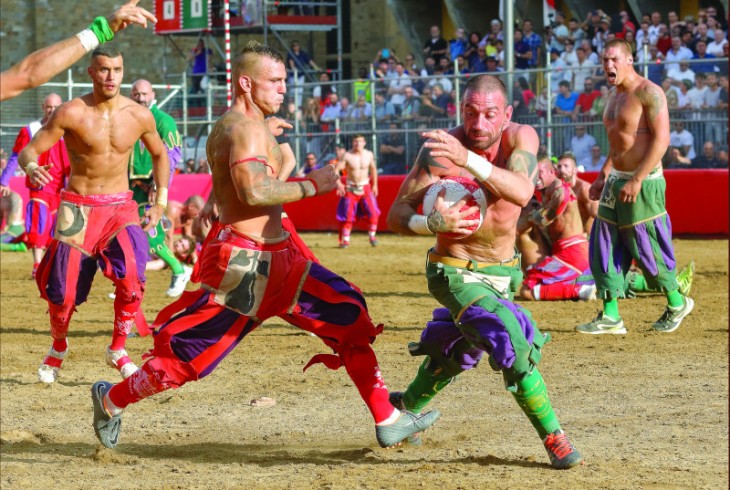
[0,94,70,278]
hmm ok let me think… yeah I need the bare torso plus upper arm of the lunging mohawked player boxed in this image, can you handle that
[206,111,282,238]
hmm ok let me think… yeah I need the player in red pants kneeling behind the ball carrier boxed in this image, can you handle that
[517,157,596,301]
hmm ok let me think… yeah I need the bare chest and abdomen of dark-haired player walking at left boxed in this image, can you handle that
[60,94,152,195]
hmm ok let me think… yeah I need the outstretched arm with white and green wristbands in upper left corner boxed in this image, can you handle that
[0,0,157,100]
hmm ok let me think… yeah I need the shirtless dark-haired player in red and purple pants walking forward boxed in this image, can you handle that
[18,45,169,383]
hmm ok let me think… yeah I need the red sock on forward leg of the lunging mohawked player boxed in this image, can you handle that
[340,345,395,424]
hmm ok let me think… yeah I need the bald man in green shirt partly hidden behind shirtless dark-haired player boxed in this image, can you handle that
[129,79,192,298]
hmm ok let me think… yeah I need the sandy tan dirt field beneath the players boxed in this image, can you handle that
[0,234,728,489]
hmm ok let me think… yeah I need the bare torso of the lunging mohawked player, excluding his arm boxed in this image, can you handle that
[206,111,282,238]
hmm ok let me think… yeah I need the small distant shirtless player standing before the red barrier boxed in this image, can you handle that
[336,134,380,248]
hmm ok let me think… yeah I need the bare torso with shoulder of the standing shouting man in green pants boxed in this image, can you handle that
[603,77,669,171]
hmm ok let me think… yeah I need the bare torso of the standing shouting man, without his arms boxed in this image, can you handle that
[603,77,660,172]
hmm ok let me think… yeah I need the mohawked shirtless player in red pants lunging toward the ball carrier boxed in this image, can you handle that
[91,41,439,447]
